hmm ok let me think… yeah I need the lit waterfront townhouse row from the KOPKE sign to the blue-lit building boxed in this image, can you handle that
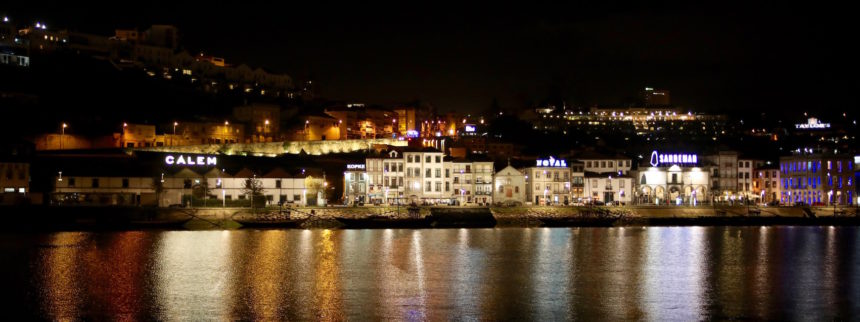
[344,149,855,206]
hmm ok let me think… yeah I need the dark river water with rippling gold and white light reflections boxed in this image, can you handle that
[0,227,860,321]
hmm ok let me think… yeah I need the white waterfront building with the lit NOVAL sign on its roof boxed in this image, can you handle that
[522,157,571,205]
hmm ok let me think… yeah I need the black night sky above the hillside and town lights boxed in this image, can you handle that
[5,2,860,112]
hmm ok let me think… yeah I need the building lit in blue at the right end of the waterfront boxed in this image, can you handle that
[779,153,855,205]
